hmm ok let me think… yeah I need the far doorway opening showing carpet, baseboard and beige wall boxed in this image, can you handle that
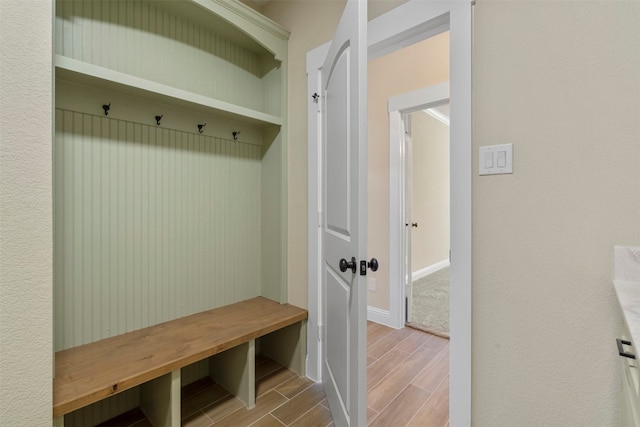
[402,101,450,338]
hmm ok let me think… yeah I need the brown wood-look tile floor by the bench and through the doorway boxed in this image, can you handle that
[102,322,449,427]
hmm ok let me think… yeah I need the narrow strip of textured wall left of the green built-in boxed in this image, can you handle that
[0,0,53,426]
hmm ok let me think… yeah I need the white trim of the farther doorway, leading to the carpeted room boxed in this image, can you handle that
[387,83,448,328]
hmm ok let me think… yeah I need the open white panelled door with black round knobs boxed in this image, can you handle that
[320,0,367,426]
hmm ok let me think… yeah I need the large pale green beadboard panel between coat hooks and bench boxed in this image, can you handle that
[54,109,262,351]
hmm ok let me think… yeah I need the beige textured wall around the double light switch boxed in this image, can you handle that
[472,0,640,427]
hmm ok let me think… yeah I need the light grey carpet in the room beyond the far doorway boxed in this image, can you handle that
[407,267,449,338]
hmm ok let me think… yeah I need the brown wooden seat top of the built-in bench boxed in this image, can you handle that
[53,297,307,417]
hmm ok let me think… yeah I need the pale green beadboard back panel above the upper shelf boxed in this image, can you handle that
[55,0,272,116]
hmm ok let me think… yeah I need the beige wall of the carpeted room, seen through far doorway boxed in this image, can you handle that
[411,111,449,272]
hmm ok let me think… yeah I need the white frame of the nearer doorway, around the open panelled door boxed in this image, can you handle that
[307,0,472,427]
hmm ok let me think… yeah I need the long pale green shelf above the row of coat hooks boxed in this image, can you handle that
[54,55,282,126]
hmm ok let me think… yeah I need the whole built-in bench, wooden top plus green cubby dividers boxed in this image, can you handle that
[53,297,307,426]
